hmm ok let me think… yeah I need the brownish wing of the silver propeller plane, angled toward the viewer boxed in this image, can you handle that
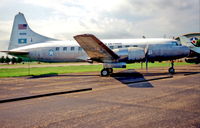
[74,34,119,62]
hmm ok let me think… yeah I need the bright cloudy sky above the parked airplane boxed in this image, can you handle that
[0,0,200,50]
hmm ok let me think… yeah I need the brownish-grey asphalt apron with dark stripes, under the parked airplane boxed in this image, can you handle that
[0,65,200,128]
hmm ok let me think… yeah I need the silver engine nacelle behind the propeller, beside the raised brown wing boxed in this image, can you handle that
[113,47,145,61]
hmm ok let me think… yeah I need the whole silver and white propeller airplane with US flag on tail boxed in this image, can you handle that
[1,12,190,76]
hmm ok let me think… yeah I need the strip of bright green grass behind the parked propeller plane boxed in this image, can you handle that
[0,62,189,77]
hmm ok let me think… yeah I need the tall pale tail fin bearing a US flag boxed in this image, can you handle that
[8,12,56,50]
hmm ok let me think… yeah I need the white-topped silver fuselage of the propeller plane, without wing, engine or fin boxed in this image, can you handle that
[11,38,189,62]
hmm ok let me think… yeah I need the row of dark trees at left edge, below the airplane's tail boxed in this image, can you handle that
[0,56,23,64]
